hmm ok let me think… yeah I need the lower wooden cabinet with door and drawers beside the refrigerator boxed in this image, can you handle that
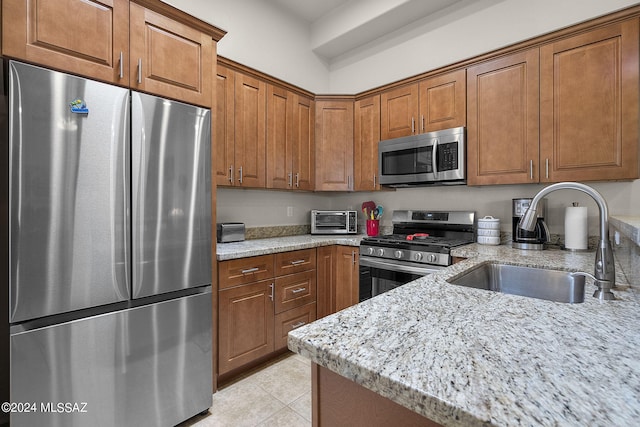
[217,249,316,378]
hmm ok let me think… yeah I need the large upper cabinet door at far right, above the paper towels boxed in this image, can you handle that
[540,18,638,181]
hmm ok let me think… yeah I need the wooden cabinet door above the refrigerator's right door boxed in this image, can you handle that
[129,3,215,107]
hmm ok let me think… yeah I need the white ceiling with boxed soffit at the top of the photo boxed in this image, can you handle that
[265,0,468,60]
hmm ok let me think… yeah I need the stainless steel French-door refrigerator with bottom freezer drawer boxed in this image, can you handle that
[0,61,212,426]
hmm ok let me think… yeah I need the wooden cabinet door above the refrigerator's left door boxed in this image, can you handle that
[2,0,129,86]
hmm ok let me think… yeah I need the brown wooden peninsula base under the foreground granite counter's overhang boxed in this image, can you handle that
[311,363,440,427]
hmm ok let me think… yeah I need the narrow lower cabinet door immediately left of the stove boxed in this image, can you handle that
[333,246,360,312]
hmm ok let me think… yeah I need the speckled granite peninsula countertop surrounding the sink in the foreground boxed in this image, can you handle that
[289,244,640,426]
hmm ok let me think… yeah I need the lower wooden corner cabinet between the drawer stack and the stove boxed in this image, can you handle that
[316,246,360,318]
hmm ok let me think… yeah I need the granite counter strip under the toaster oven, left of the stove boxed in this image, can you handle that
[216,234,364,261]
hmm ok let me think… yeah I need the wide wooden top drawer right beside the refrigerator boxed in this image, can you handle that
[218,255,274,289]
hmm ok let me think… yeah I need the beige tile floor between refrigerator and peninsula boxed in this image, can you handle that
[180,353,311,427]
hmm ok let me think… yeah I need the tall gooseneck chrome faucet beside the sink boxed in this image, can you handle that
[518,182,616,300]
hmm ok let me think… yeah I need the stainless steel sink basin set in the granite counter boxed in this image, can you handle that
[448,263,585,303]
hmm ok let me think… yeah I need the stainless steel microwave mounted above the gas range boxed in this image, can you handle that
[378,127,466,187]
